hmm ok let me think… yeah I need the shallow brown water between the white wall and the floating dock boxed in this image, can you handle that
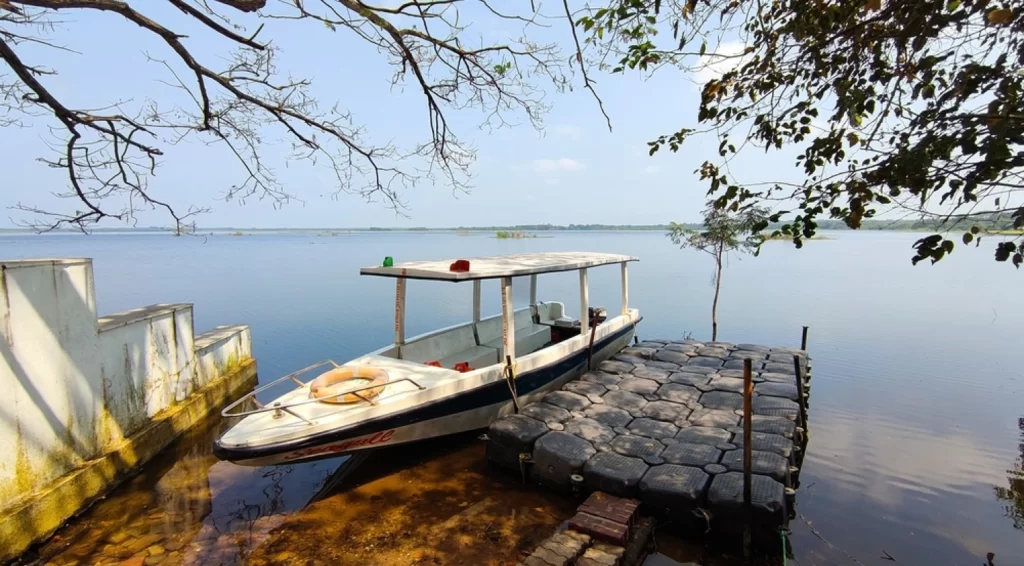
[25,427,573,566]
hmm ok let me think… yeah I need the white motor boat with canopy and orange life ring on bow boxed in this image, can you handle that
[214,252,640,466]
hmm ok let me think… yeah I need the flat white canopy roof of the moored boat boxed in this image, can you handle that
[359,252,637,281]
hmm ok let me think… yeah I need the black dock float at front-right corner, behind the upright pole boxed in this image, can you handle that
[708,472,785,524]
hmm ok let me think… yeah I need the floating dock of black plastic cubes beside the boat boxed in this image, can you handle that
[487,340,809,539]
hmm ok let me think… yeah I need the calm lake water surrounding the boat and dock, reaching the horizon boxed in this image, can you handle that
[0,231,1024,565]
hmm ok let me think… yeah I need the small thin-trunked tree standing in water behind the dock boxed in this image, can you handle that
[668,204,770,341]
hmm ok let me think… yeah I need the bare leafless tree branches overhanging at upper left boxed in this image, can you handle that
[0,0,567,230]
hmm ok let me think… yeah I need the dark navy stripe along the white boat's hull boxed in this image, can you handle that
[213,324,635,462]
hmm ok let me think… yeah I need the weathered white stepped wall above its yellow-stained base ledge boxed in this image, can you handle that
[0,259,252,511]
